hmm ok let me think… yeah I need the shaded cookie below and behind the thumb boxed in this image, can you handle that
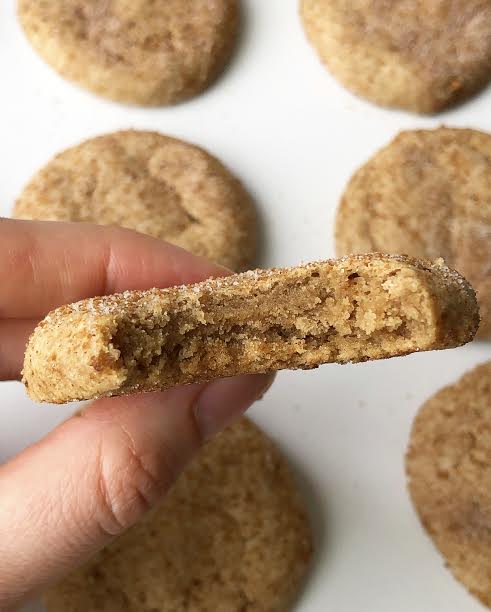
[44,418,311,612]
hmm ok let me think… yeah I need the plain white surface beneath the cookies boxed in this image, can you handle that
[0,0,491,612]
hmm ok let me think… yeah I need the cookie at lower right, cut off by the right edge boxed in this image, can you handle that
[406,361,491,607]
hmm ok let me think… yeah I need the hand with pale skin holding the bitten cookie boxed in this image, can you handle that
[0,219,272,611]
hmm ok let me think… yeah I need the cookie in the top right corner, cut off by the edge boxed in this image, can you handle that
[301,0,491,113]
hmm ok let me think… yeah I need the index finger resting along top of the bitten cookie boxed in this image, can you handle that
[0,219,227,319]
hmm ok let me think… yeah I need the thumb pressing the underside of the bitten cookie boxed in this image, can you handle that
[0,375,272,610]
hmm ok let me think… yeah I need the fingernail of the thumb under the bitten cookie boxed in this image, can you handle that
[194,374,274,440]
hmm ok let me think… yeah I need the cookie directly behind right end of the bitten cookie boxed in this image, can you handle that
[336,128,491,338]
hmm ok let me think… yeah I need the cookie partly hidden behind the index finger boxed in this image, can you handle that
[14,131,257,270]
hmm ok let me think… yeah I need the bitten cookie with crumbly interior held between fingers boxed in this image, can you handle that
[24,255,479,403]
